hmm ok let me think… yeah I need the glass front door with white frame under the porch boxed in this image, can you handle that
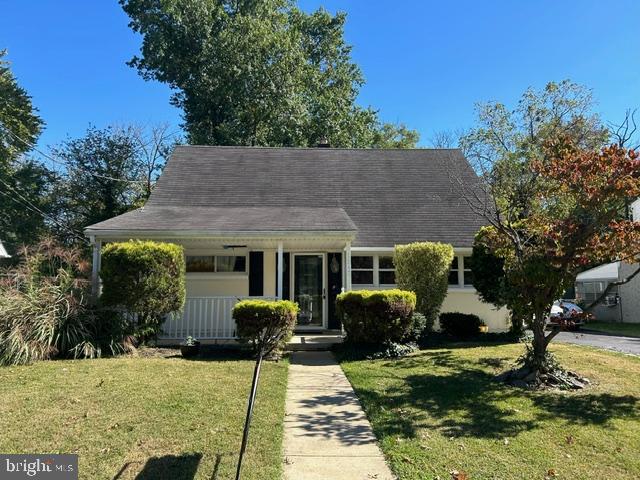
[293,254,324,329]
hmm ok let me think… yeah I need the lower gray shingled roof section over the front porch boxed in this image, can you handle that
[86,204,357,237]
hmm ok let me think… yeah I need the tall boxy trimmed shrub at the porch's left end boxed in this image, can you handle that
[100,240,186,342]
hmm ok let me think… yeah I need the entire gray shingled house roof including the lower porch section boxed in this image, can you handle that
[89,146,483,247]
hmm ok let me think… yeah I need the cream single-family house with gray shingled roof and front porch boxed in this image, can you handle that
[86,146,508,339]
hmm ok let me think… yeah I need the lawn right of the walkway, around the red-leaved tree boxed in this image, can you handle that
[342,344,640,480]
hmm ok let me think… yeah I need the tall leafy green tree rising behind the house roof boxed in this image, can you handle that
[120,0,417,148]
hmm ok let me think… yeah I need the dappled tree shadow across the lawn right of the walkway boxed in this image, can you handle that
[358,351,640,438]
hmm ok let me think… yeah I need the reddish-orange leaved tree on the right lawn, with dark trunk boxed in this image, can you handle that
[481,138,640,382]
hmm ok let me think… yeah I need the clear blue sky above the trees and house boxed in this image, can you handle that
[0,0,640,146]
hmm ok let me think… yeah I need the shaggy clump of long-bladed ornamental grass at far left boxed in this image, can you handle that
[0,240,134,365]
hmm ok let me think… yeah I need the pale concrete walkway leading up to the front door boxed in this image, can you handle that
[284,352,395,480]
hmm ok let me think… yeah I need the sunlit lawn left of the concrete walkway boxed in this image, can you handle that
[0,348,287,480]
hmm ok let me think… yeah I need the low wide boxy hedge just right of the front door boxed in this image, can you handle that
[336,289,416,344]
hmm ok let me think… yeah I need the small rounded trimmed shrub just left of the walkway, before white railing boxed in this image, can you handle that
[232,300,299,356]
